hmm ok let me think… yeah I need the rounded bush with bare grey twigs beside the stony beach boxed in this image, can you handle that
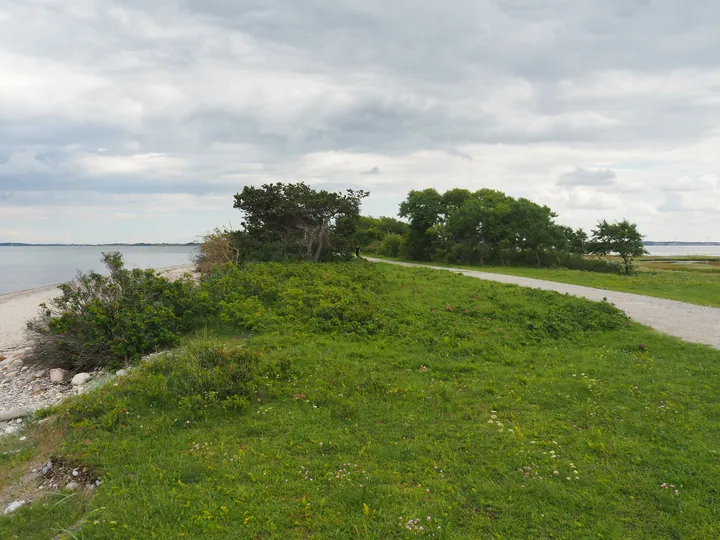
[27,252,211,372]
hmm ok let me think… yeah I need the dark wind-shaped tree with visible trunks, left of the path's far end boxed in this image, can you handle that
[234,183,369,261]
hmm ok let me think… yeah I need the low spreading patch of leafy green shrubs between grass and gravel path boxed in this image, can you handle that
[202,262,627,346]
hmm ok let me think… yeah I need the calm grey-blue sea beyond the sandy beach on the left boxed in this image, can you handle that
[0,246,195,294]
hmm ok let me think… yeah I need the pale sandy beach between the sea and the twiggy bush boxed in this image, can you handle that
[0,264,194,359]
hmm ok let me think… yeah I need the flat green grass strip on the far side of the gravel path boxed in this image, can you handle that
[373,255,720,307]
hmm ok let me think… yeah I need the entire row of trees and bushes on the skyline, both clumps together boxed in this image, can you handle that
[196,183,645,273]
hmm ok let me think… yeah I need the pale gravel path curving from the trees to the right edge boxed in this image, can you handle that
[367,258,720,349]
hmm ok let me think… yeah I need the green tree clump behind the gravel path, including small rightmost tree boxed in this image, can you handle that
[357,189,643,272]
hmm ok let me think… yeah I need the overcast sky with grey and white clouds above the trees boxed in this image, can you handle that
[0,0,720,243]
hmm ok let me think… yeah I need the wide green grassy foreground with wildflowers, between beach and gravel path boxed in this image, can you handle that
[0,263,720,540]
